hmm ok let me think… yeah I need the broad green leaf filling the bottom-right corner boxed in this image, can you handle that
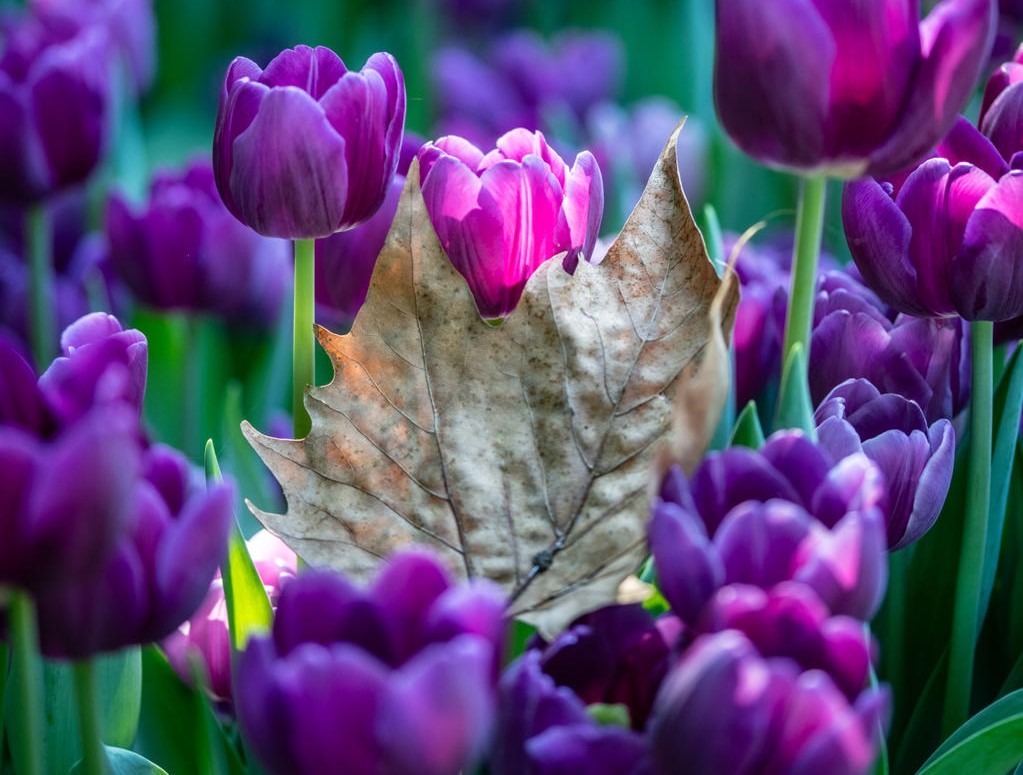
[918,690,1023,775]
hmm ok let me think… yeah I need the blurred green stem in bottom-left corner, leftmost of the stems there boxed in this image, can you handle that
[7,589,43,775]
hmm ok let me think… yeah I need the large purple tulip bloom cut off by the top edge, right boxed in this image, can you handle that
[714,0,996,178]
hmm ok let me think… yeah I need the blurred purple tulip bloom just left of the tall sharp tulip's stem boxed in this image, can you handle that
[106,162,292,328]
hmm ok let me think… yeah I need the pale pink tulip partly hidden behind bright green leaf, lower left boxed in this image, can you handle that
[161,531,298,701]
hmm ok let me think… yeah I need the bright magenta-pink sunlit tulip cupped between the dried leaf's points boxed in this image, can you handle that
[419,129,604,319]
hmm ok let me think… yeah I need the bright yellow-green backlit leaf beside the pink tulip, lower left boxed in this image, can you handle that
[206,441,273,653]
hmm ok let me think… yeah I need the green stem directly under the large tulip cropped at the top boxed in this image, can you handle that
[782,177,828,364]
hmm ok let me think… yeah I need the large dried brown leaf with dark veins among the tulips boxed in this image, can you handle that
[244,122,738,634]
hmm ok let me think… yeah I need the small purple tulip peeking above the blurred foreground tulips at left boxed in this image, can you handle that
[39,312,148,424]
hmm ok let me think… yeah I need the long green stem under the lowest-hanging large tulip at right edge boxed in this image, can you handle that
[943,320,993,736]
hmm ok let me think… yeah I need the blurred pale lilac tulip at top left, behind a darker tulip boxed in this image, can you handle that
[30,0,157,96]
